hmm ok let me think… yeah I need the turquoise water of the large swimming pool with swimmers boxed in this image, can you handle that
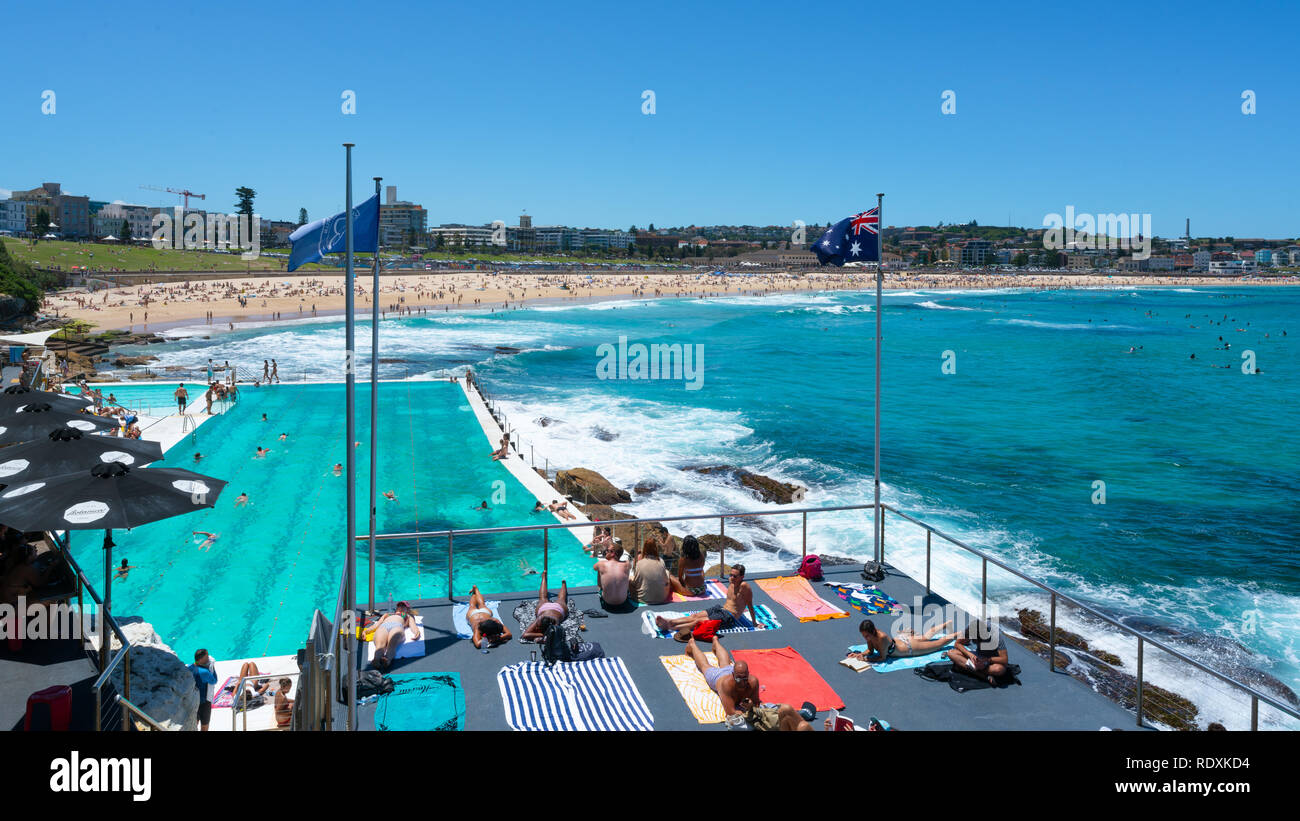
[72,382,592,659]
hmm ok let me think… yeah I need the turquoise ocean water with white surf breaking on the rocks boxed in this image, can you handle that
[114,287,1300,721]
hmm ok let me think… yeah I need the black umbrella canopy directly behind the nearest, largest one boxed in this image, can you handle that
[0,427,163,487]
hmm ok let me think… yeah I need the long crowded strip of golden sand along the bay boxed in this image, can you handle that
[43,269,1300,333]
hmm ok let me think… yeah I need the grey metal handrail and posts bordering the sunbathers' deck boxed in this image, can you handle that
[334,503,1300,730]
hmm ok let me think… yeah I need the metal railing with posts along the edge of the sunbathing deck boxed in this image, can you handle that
[335,503,1300,730]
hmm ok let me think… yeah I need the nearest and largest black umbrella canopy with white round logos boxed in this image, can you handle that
[0,461,226,530]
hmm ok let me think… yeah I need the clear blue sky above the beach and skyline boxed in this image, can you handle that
[0,0,1300,236]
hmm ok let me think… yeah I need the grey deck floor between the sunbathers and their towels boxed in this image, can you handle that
[335,565,1135,731]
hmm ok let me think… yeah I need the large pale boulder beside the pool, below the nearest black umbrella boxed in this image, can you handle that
[111,621,199,730]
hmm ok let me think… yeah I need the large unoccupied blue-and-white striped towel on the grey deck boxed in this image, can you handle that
[497,656,654,731]
